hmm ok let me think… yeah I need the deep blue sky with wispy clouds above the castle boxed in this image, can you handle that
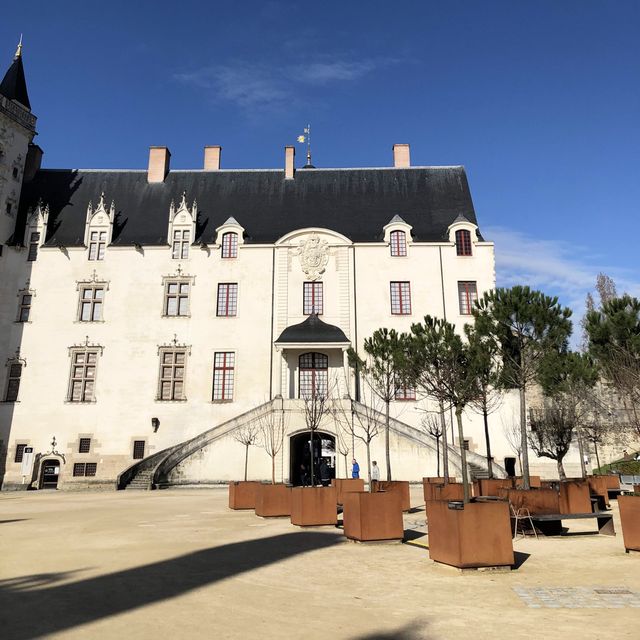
[0,0,640,338]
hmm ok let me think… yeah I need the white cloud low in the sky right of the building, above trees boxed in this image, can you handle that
[482,227,640,341]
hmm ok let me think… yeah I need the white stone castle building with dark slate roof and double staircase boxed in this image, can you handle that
[0,48,584,489]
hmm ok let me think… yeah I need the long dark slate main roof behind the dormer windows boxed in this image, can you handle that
[16,167,477,246]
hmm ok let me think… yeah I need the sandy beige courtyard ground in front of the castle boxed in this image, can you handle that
[0,487,640,640]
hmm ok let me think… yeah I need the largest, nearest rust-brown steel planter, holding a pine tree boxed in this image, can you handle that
[428,501,515,569]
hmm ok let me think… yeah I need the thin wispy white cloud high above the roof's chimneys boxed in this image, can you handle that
[173,56,395,114]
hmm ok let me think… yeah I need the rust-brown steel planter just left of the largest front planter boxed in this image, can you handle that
[342,491,404,542]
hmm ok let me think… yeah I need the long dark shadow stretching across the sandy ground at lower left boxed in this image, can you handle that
[0,532,343,640]
